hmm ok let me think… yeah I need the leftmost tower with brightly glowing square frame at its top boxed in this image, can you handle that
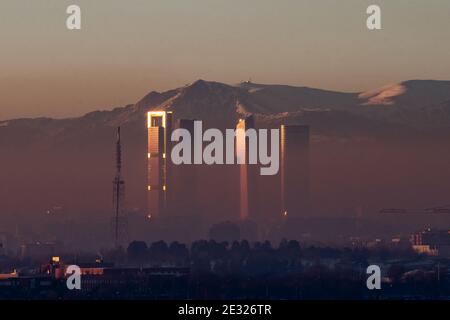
[147,111,172,218]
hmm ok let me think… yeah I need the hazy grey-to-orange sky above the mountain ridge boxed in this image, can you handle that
[0,0,450,119]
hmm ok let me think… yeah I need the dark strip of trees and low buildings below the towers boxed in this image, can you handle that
[0,240,450,300]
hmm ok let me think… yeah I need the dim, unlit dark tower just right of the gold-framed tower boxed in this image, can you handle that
[168,119,198,217]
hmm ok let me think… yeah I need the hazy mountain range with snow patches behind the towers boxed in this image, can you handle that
[0,80,450,146]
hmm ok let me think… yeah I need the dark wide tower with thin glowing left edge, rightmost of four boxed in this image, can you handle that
[281,125,310,218]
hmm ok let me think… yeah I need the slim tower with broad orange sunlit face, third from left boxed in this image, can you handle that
[236,116,259,220]
